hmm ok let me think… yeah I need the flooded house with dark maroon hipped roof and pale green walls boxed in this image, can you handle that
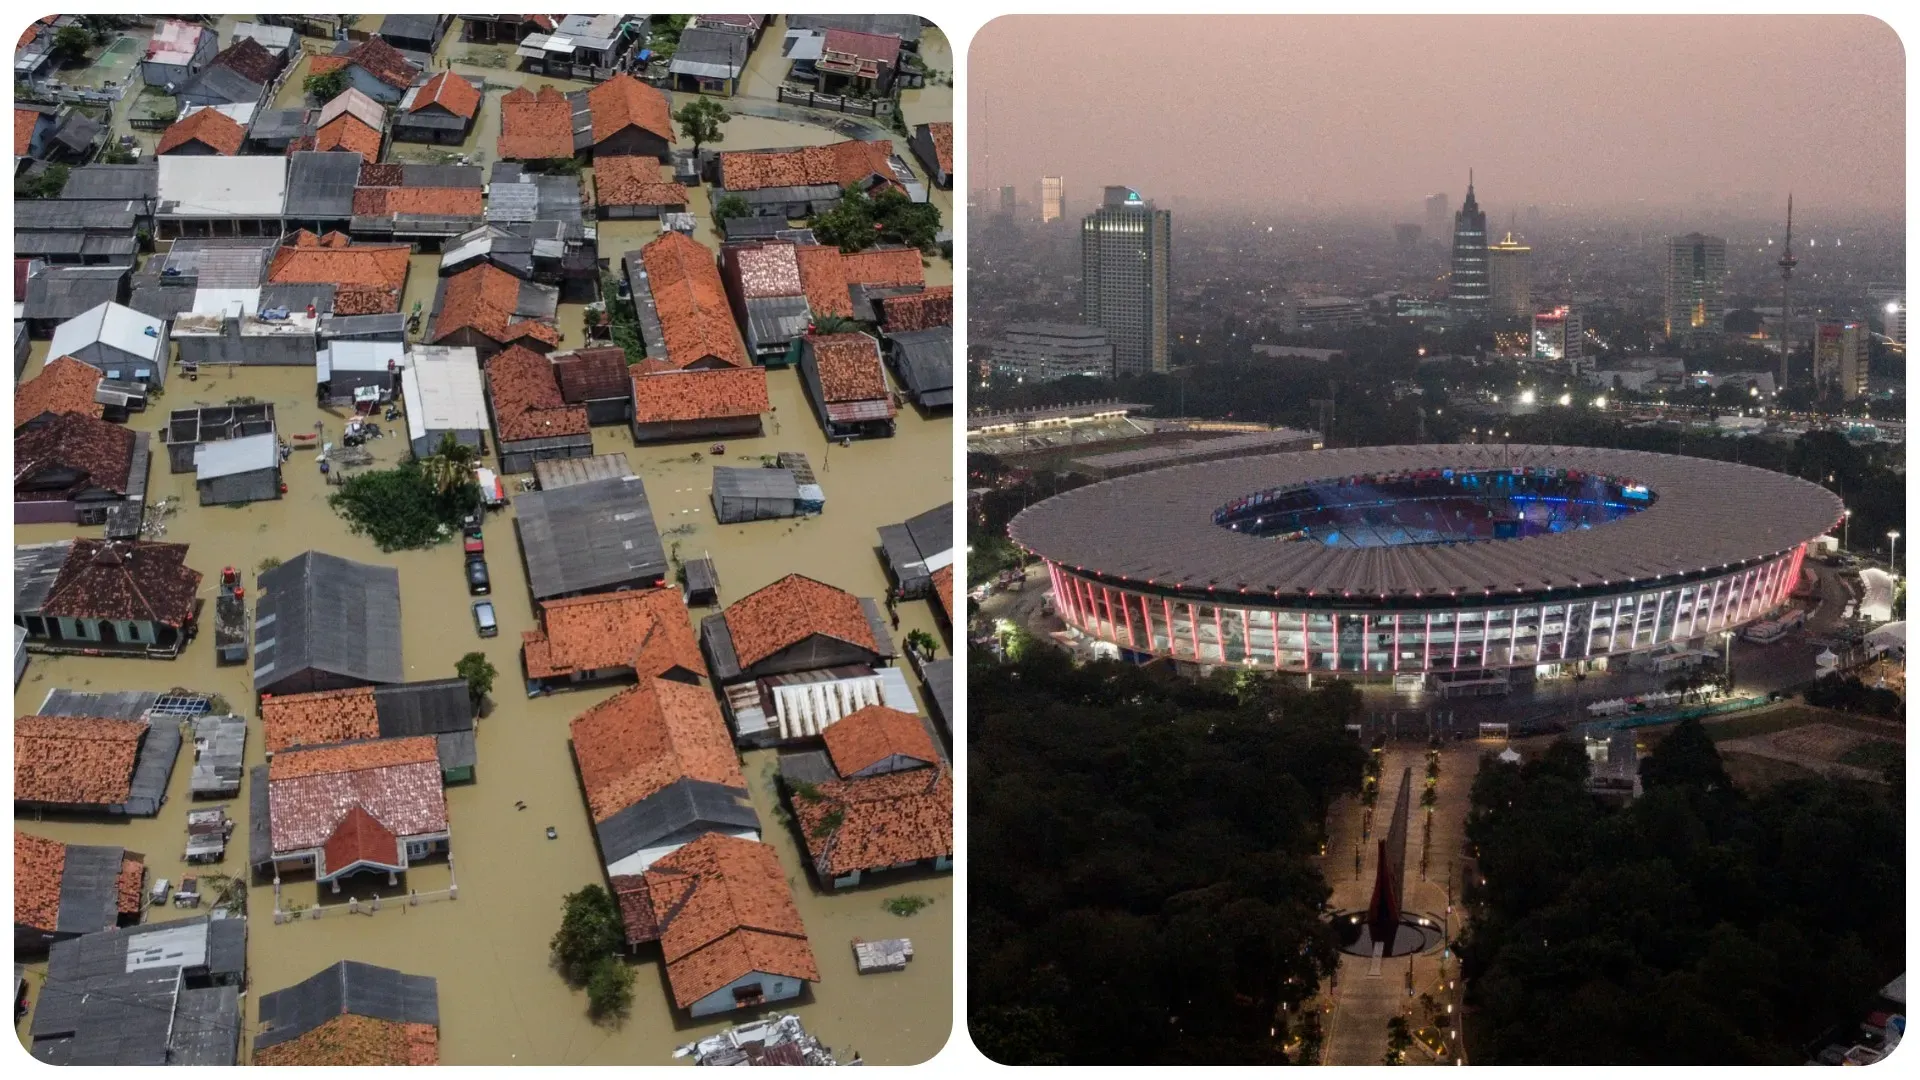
[13,536,200,659]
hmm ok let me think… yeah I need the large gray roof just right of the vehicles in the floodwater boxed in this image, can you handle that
[515,477,666,600]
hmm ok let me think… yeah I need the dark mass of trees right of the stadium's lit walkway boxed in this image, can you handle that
[1461,721,1907,1065]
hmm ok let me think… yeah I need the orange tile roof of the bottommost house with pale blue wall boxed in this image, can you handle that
[641,832,820,1009]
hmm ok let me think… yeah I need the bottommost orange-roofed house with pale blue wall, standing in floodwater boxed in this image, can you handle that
[612,832,820,1017]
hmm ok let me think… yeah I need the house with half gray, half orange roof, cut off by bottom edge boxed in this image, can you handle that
[253,961,440,1067]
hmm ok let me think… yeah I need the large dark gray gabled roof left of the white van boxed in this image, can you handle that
[253,552,407,692]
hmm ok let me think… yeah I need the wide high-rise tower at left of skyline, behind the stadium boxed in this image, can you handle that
[1081,186,1173,375]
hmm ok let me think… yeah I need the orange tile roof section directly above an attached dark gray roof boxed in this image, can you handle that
[568,678,747,821]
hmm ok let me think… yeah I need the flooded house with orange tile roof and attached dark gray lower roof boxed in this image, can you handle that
[568,678,760,878]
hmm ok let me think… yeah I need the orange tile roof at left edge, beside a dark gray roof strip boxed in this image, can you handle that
[13,717,146,805]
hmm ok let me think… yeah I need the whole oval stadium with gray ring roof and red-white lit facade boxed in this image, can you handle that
[1008,446,1841,682]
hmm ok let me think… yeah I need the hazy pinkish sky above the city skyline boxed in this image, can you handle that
[966,15,1907,221]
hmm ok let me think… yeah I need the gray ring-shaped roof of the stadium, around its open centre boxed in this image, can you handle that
[1008,446,1841,598]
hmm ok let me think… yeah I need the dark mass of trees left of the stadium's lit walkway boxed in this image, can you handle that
[968,648,1365,1065]
